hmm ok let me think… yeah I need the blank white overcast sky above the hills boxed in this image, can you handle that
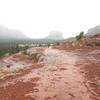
[0,0,100,38]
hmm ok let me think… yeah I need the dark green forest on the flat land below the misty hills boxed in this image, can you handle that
[0,39,65,56]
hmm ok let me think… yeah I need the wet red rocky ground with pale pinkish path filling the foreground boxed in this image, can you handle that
[0,48,100,100]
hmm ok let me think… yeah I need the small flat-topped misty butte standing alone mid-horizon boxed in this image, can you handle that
[46,31,64,40]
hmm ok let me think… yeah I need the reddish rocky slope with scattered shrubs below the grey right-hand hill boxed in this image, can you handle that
[54,30,100,50]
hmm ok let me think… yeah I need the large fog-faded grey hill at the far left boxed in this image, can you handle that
[0,26,27,40]
